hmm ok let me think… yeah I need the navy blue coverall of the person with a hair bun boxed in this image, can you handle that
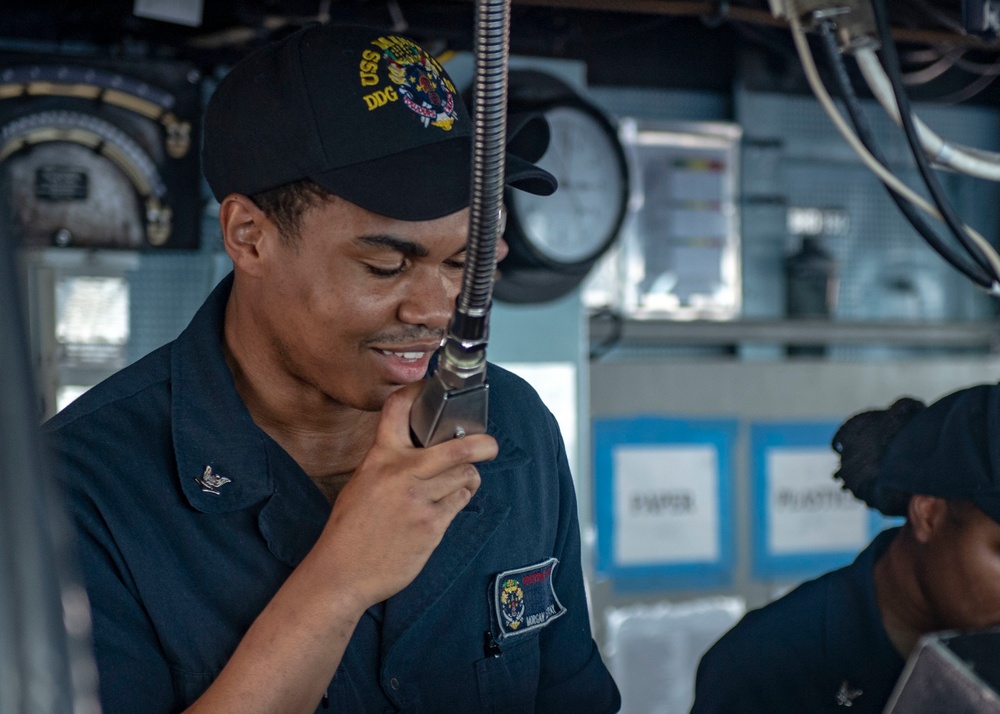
[691,528,904,714]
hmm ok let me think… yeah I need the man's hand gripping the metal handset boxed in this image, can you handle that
[324,383,497,607]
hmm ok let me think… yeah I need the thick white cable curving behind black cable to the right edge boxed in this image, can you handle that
[854,48,1000,181]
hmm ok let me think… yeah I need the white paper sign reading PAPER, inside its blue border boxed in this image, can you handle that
[613,444,721,565]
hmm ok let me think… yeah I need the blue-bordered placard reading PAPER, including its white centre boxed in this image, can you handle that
[594,416,737,590]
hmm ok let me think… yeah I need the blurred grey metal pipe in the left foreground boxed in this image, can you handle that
[0,230,100,714]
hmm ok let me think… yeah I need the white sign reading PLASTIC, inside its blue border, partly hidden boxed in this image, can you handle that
[766,448,870,555]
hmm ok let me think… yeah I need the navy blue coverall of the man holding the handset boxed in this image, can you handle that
[45,276,620,714]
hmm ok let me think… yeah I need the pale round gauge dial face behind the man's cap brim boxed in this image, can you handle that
[510,106,627,265]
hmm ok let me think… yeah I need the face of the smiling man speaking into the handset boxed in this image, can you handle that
[268,199,469,410]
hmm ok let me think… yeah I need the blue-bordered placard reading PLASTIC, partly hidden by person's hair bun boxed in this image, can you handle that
[750,422,889,577]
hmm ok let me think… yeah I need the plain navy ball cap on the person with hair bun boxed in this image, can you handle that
[878,384,1000,522]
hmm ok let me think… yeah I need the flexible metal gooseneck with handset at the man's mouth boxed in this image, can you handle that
[410,0,510,446]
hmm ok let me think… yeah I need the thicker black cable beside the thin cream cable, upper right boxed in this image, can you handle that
[819,21,993,288]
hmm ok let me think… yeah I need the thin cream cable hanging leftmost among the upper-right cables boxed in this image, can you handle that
[788,14,1000,286]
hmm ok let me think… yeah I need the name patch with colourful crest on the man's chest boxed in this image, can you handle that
[493,558,566,637]
